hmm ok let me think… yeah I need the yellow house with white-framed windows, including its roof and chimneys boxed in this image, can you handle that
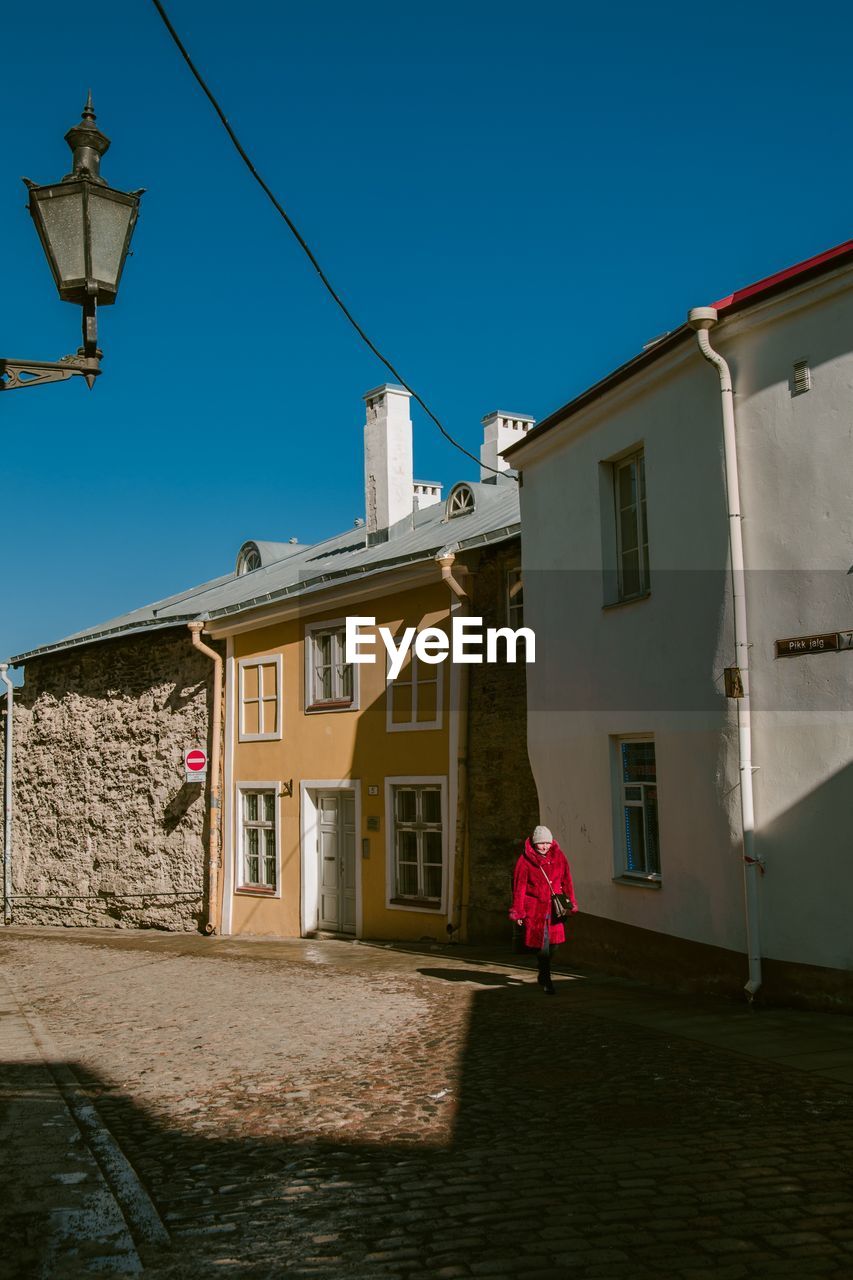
[204,387,530,940]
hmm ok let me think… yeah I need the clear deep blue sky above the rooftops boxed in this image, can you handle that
[0,0,853,654]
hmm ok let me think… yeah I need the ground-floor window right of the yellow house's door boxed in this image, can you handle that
[391,782,444,909]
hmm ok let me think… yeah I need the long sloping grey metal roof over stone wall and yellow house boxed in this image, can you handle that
[10,477,520,663]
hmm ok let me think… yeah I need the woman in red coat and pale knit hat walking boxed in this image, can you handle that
[510,827,578,996]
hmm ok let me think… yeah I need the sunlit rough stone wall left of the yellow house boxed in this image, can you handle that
[0,627,214,929]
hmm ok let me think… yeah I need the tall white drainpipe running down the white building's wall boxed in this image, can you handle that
[688,307,763,1001]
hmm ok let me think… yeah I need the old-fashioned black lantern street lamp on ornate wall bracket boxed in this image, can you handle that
[0,92,142,390]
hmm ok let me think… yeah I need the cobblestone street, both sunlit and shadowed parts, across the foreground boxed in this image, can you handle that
[0,929,853,1280]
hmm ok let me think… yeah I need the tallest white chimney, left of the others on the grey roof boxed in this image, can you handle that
[364,384,414,541]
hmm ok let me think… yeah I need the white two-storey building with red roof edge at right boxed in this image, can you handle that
[507,242,853,1004]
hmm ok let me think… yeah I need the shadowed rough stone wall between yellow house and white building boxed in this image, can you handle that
[469,541,539,943]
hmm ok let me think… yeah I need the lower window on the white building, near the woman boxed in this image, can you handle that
[615,737,661,879]
